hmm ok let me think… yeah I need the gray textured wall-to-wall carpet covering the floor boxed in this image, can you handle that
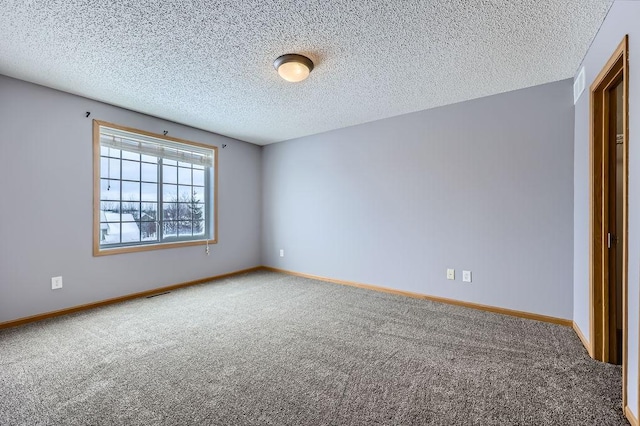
[0,271,627,426]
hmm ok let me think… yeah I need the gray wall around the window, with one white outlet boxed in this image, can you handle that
[0,76,261,322]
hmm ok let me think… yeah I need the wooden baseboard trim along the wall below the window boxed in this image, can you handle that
[0,266,262,330]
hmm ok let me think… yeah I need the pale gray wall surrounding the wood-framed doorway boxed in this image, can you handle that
[573,0,640,412]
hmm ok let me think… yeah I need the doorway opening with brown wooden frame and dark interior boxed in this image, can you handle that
[590,36,629,406]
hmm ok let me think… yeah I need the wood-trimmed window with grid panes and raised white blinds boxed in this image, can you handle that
[93,120,217,255]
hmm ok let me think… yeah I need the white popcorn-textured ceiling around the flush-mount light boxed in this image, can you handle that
[0,0,612,144]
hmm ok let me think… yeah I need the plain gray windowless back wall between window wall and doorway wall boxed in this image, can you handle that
[262,80,574,319]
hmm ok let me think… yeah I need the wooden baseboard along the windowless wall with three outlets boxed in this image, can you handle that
[264,266,573,327]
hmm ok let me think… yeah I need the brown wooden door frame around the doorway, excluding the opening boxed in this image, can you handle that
[589,35,629,409]
